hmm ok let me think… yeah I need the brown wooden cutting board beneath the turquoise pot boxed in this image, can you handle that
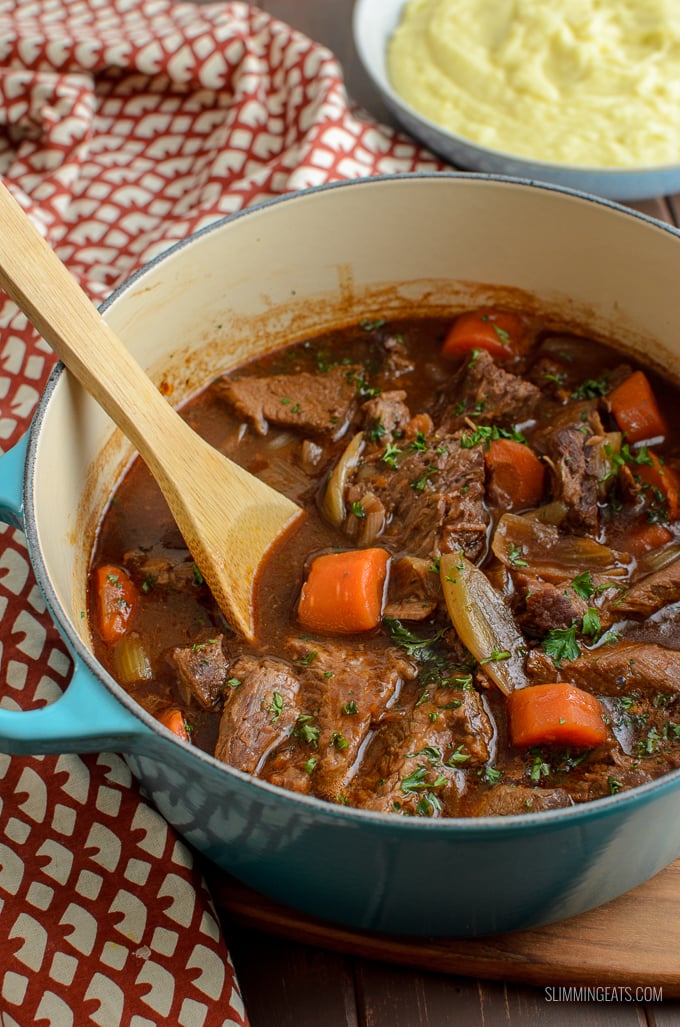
[207,860,680,998]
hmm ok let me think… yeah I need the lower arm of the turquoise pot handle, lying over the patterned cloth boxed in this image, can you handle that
[0,657,148,755]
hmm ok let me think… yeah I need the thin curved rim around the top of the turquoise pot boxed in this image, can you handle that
[15,172,680,839]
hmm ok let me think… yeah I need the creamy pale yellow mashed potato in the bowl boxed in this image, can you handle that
[388,0,680,167]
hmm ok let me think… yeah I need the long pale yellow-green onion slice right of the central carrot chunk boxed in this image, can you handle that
[440,553,528,695]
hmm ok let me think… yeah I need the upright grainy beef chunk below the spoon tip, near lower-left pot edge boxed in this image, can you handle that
[215,656,300,773]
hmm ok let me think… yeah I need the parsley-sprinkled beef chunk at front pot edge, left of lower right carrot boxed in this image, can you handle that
[350,686,494,816]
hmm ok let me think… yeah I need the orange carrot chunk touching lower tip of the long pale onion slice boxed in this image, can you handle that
[507,682,607,749]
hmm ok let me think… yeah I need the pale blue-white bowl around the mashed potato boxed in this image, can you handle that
[352,0,680,200]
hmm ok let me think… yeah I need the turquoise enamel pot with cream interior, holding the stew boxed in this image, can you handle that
[0,174,680,937]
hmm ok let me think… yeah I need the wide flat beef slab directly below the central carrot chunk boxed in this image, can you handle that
[262,639,416,802]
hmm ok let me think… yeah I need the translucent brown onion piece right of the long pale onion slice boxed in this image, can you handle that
[491,514,631,582]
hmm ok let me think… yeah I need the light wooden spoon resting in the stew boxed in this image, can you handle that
[0,184,302,640]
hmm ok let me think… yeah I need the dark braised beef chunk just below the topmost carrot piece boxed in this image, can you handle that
[433,350,541,432]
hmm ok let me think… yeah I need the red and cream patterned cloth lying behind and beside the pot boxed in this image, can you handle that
[0,0,440,1027]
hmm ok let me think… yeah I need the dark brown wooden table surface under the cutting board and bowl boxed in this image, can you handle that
[206,0,680,1027]
